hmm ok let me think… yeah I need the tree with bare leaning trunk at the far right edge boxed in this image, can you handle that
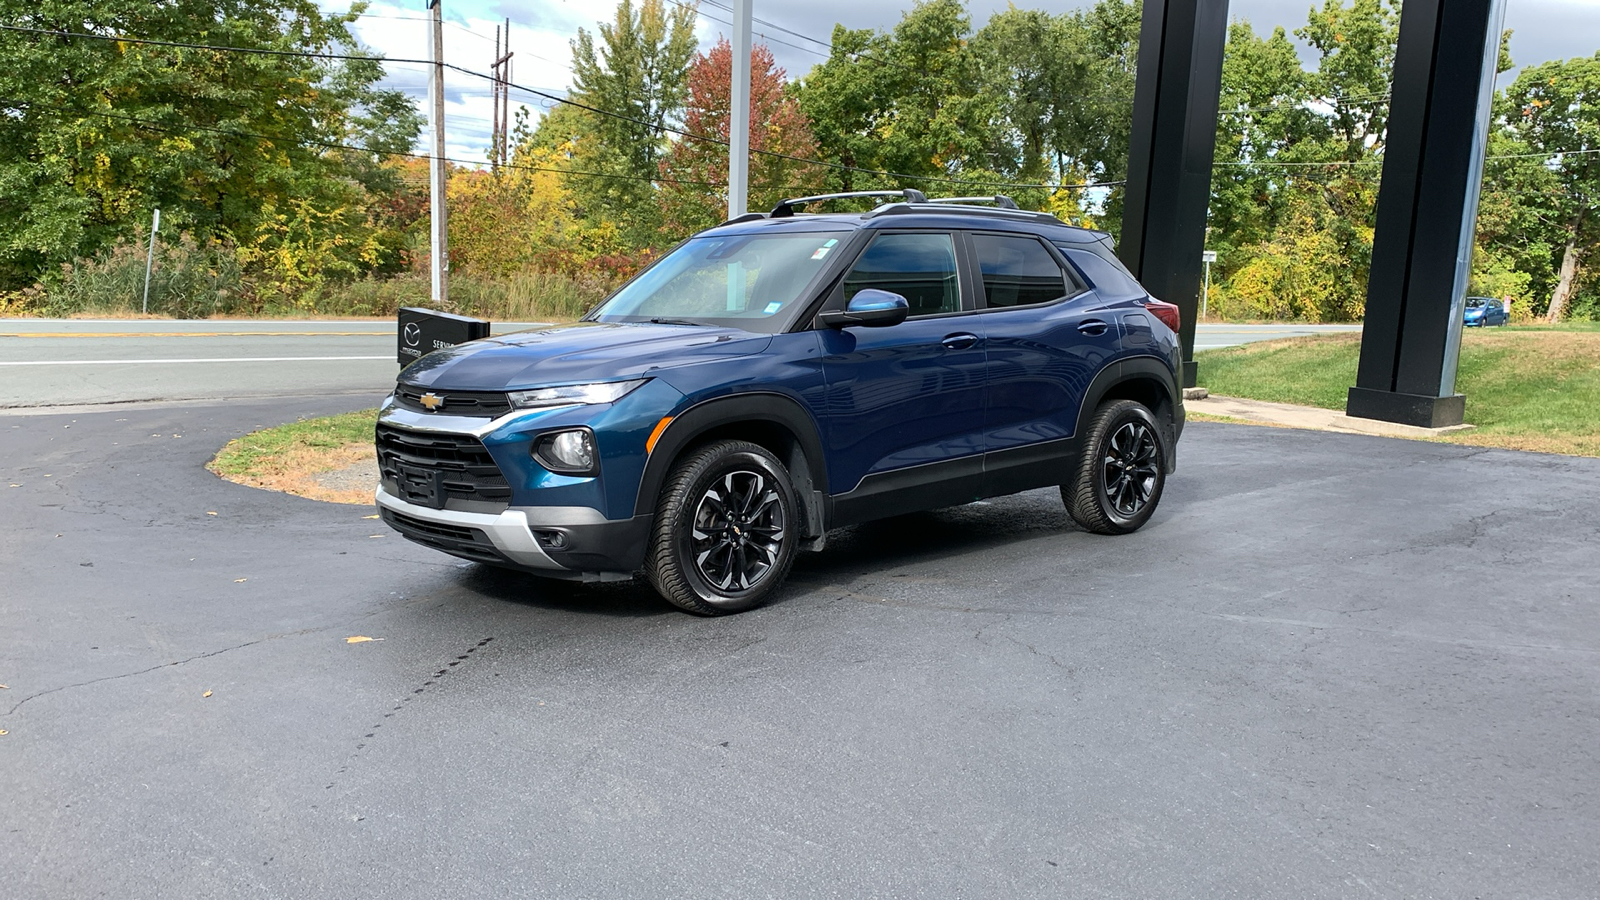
[1506,53,1600,322]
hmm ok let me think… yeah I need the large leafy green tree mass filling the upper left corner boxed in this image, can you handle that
[0,0,419,288]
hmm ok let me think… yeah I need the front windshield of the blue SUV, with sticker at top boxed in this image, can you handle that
[589,231,850,333]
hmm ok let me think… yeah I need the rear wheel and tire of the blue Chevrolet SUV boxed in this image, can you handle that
[1061,400,1166,535]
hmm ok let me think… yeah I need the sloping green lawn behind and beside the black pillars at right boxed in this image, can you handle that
[1197,323,1600,456]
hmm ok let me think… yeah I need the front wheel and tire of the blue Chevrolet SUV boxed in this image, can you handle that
[645,440,800,615]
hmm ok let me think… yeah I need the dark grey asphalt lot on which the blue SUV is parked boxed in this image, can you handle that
[0,396,1600,900]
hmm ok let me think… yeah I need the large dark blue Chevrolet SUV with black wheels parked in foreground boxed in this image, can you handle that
[376,191,1184,615]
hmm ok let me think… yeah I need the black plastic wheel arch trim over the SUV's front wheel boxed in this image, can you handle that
[634,391,827,536]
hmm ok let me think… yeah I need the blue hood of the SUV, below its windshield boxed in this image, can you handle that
[400,322,773,391]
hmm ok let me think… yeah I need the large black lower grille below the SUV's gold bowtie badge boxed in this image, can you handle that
[378,424,510,512]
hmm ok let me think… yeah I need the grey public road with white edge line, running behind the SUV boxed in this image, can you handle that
[0,319,1360,408]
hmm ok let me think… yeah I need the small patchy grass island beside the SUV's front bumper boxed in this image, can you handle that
[206,410,378,503]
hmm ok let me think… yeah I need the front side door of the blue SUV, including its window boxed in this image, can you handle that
[819,231,986,506]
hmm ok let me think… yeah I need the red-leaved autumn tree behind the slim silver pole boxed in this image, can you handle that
[661,38,822,237]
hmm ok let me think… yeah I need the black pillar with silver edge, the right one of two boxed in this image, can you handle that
[1346,0,1506,428]
